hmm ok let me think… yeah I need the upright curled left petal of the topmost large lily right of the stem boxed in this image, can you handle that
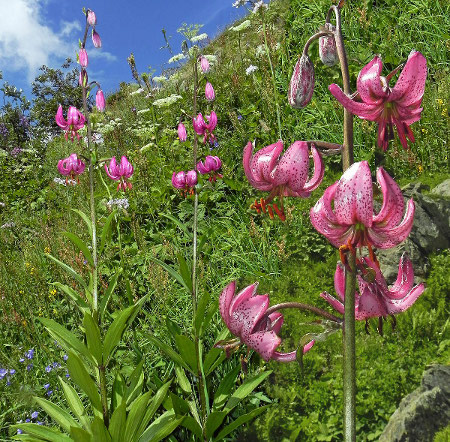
[356,55,389,105]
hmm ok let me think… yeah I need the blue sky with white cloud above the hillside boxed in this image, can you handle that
[0,0,247,99]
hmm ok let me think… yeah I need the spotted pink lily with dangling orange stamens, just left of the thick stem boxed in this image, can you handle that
[243,141,325,221]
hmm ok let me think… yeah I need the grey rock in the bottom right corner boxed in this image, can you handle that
[379,365,450,442]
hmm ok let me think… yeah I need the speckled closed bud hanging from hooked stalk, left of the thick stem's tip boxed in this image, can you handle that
[288,54,315,109]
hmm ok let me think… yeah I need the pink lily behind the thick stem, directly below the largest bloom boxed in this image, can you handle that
[320,254,425,321]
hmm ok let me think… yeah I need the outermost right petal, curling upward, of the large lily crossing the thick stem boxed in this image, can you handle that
[367,199,415,249]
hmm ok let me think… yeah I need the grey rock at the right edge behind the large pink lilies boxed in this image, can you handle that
[377,180,450,283]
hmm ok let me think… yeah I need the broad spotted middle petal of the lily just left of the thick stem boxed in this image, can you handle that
[270,141,309,192]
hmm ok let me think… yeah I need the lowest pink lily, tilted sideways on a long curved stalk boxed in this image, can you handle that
[216,281,314,362]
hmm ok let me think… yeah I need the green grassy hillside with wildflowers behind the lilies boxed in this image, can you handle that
[0,0,450,441]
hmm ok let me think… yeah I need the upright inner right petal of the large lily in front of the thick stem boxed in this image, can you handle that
[373,167,405,227]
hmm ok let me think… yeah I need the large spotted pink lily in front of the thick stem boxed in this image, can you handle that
[310,161,415,249]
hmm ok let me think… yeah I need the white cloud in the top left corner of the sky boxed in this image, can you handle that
[0,0,116,81]
